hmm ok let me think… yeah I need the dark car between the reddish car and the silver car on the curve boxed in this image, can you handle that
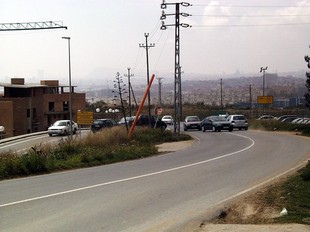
[201,116,233,132]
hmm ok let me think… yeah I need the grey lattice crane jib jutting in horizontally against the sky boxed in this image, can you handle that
[0,21,67,31]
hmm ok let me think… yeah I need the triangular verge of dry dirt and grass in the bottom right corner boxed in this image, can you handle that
[211,161,310,225]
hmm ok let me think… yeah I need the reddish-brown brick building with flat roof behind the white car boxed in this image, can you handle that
[0,78,86,137]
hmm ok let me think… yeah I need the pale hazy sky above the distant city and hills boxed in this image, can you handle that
[0,0,310,85]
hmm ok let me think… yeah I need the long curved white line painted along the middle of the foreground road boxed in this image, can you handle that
[0,134,255,208]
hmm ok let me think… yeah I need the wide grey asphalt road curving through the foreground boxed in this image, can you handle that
[0,131,310,232]
